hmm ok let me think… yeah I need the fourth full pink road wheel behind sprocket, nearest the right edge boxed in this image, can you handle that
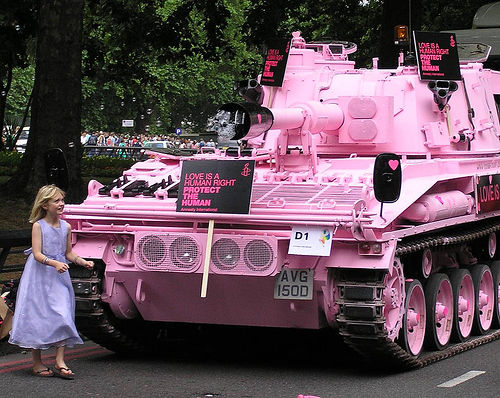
[471,264,495,334]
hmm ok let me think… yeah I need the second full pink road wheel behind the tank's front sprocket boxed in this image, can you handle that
[425,273,453,350]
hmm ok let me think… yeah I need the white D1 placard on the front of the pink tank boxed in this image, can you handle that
[288,226,333,256]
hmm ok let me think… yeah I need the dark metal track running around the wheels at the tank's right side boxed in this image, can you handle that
[337,221,500,369]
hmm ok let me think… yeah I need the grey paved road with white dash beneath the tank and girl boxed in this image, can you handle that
[0,335,500,398]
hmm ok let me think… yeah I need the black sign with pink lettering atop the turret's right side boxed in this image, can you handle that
[413,32,462,80]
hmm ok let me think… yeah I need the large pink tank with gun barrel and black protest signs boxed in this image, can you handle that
[65,32,500,367]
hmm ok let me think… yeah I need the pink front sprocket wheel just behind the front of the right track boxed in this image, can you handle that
[383,257,405,341]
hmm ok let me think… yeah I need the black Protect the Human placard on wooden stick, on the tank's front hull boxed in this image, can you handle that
[177,160,255,214]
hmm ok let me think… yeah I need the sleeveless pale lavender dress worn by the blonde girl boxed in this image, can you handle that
[9,220,83,349]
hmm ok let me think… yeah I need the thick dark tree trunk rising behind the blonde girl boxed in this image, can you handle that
[3,0,84,203]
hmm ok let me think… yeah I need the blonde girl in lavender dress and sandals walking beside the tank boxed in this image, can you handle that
[9,185,94,379]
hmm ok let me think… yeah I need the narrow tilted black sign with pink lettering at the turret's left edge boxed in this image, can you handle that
[260,39,290,87]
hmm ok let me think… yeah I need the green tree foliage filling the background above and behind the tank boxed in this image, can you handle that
[0,0,496,133]
